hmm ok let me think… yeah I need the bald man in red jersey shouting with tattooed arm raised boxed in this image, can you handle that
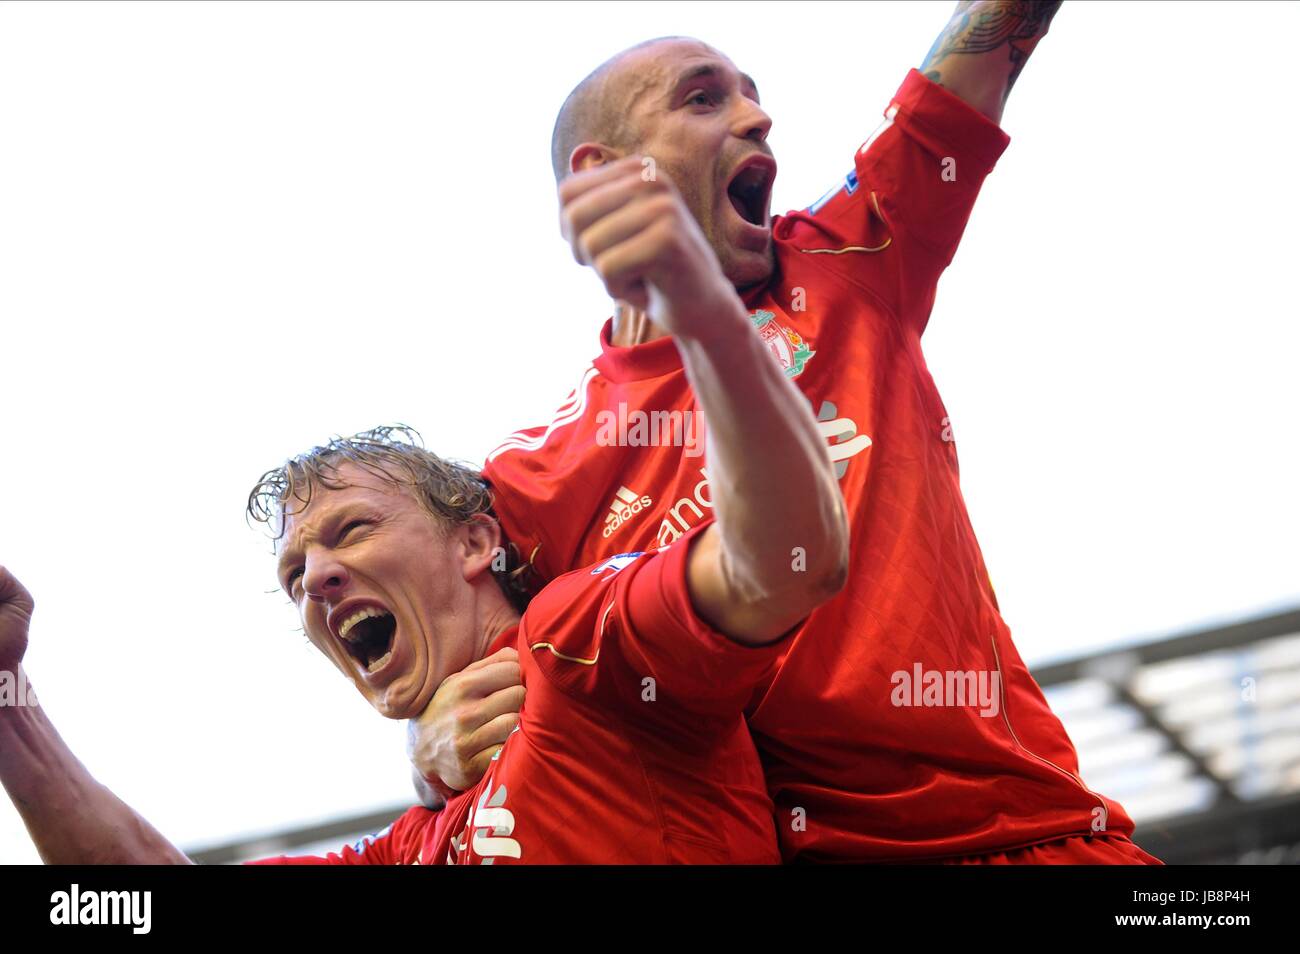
[411,1,1158,863]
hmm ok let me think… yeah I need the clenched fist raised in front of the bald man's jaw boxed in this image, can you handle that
[559,156,745,348]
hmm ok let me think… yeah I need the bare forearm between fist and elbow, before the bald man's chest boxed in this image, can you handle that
[677,302,848,621]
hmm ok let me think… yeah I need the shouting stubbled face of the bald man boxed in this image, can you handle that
[608,40,776,289]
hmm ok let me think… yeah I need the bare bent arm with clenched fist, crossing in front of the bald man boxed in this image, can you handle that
[560,156,849,645]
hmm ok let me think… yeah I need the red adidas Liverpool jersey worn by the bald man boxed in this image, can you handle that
[485,70,1132,860]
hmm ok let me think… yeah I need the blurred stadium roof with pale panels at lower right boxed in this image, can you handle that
[1034,610,1300,864]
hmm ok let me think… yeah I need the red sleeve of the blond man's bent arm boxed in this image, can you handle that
[525,521,785,734]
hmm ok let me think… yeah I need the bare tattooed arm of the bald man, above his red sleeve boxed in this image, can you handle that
[920,0,1061,122]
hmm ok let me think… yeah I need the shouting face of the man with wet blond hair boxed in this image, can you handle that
[277,463,484,719]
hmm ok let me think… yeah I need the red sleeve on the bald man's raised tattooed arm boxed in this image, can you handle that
[777,69,1011,334]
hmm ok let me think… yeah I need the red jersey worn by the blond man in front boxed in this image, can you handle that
[253,529,783,864]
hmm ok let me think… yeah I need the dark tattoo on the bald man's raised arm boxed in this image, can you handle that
[920,0,1061,103]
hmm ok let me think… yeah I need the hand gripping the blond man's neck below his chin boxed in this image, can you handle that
[407,647,524,802]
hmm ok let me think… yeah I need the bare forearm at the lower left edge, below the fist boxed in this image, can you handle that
[0,670,189,864]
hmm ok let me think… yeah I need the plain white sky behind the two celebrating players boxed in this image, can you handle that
[0,1,1300,862]
